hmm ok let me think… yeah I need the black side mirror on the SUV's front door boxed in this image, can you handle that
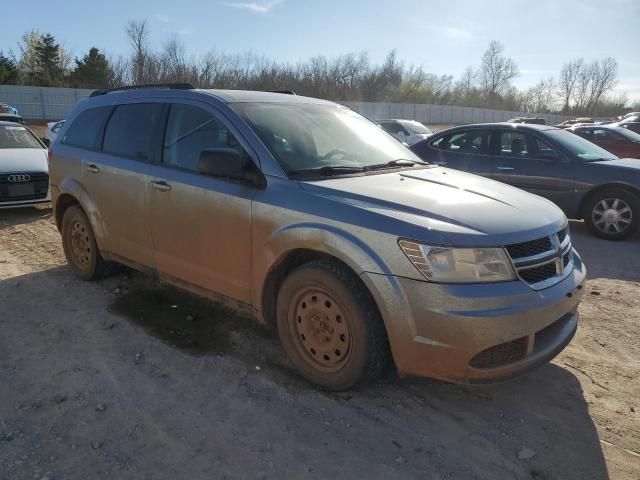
[198,148,264,186]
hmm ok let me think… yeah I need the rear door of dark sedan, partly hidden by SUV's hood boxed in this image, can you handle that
[428,128,492,177]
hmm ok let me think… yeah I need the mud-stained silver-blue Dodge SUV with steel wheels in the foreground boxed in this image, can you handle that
[50,84,585,390]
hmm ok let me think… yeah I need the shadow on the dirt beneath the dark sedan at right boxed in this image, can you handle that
[570,221,640,281]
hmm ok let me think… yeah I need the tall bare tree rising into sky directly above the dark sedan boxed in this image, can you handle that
[478,40,520,104]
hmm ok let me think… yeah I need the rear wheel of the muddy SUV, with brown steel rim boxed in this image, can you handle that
[61,205,113,280]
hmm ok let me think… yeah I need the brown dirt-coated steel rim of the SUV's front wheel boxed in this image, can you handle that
[289,287,352,372]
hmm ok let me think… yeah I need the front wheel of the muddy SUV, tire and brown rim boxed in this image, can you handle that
[276,260,389,391]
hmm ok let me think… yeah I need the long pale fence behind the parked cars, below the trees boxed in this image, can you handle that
[0,85,569,125]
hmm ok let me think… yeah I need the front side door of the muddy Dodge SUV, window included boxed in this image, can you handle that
[149,102,255,303]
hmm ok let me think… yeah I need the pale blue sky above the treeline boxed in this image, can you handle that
[0,0,640,100]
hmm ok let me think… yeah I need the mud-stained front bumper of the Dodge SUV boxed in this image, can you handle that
[362,251,586,383]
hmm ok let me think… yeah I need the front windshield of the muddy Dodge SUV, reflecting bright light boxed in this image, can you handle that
[233,103,421,174]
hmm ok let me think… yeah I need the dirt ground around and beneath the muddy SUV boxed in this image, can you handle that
[0,209,640,480]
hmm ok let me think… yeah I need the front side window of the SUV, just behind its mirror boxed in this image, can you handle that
[162,104,246,172]
